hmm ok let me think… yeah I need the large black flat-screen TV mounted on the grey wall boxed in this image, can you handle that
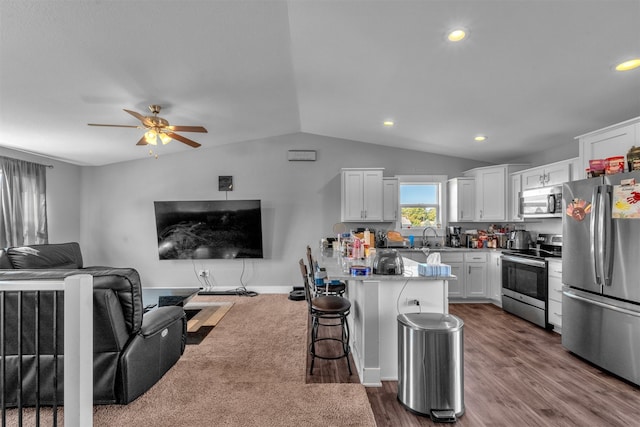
[154,200,263,259]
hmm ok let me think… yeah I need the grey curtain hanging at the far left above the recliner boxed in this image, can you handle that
[0,157,48,248]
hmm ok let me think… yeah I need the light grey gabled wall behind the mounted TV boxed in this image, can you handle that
[81,133,485,289]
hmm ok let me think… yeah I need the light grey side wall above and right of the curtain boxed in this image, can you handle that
[0,147,82,243]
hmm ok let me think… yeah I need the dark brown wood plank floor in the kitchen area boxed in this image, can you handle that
[307,304,640,427]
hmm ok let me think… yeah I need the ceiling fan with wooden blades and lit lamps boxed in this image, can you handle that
[89,105,207,148]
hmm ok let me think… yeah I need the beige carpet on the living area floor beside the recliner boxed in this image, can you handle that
[9,295,375,427]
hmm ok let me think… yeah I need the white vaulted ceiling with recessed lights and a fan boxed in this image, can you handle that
[0,0,640,165]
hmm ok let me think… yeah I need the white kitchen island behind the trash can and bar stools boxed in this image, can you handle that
[321,253,455,387]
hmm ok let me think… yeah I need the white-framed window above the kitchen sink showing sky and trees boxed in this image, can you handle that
[398,176,446,229]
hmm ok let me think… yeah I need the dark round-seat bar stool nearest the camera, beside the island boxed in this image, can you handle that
[299,259,352,375]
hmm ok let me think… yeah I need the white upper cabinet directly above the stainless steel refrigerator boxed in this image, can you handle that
[574,117,640,179]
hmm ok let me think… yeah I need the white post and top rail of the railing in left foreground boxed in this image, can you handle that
[0,274,93,427]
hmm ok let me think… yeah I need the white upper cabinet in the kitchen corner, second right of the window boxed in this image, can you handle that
[464,165,528,222]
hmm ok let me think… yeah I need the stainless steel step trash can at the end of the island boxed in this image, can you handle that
[398,313,464,422]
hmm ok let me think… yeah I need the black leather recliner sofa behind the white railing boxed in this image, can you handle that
[0,243,187,407]
